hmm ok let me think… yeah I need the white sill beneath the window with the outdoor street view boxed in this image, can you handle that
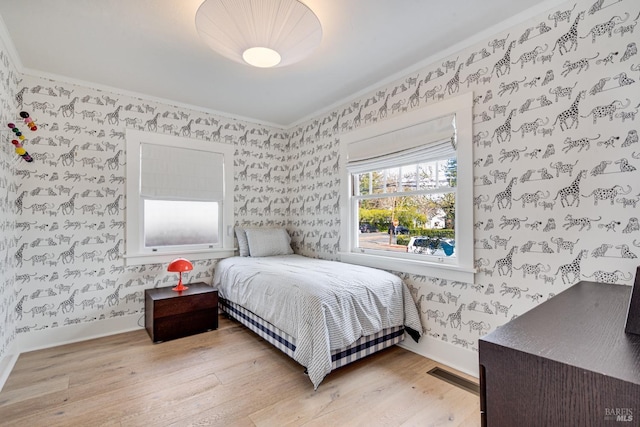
[338,252,475,283]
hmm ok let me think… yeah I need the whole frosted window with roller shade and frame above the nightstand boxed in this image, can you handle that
[125,130,233,265]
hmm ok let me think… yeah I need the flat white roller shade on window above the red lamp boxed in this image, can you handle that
[140,143,224,201]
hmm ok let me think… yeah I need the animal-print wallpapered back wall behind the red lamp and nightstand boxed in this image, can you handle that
[2,69,286,350]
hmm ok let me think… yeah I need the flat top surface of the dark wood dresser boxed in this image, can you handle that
[481,282,640,384]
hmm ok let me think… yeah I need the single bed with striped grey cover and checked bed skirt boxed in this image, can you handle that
[213,229,422,389]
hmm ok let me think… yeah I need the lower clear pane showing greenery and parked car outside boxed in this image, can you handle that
[357,192,456,257]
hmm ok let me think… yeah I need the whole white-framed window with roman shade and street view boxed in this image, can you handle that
[340,93,474,282]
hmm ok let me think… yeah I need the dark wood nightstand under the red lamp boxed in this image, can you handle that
[144,282,218,343]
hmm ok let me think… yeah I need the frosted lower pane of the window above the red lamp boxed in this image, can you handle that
[144,199,219,247]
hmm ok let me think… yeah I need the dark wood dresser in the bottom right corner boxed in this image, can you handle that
[479,282,640,427]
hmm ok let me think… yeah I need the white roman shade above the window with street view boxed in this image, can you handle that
[347,115,456,173]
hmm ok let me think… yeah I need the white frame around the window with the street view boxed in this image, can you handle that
[339,92,475,283]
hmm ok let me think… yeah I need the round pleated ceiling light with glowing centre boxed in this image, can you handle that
[196,0,322,68]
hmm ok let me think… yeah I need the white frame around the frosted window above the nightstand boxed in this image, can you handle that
[124,129,235,265]
